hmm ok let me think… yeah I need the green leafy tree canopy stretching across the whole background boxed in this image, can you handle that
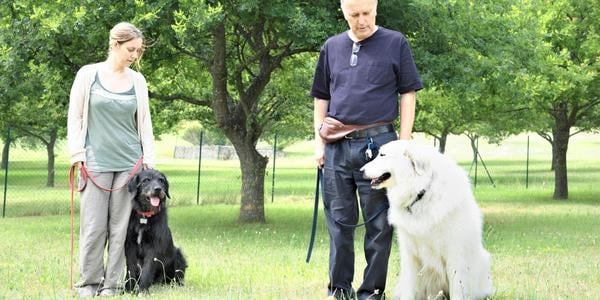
[0,0,600,203]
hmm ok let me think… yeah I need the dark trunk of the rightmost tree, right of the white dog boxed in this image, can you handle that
[552,104,570,200]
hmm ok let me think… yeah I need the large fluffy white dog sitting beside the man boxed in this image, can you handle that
[362,141,494,300]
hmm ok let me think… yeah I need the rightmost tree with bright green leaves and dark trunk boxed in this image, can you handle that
[515,0,600,199]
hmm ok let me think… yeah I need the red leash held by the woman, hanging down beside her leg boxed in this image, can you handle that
[69,156,144,290]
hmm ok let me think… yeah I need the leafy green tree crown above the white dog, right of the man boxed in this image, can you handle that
[384,0,523,152]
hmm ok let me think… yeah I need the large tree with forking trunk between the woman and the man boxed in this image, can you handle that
[140,0,343,222]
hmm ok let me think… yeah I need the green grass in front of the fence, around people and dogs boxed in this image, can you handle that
[0,198,600,299]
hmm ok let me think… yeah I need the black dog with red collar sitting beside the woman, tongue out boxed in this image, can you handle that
[125,169,187,292]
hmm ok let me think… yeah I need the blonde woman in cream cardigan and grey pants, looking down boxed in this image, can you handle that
[67,22,154,297]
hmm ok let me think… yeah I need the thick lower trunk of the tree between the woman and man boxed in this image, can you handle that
[234,144,268,223]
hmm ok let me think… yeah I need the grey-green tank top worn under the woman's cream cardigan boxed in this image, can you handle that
[85,73,142,172]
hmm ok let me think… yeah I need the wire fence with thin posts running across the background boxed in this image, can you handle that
[0,127,600,217]
